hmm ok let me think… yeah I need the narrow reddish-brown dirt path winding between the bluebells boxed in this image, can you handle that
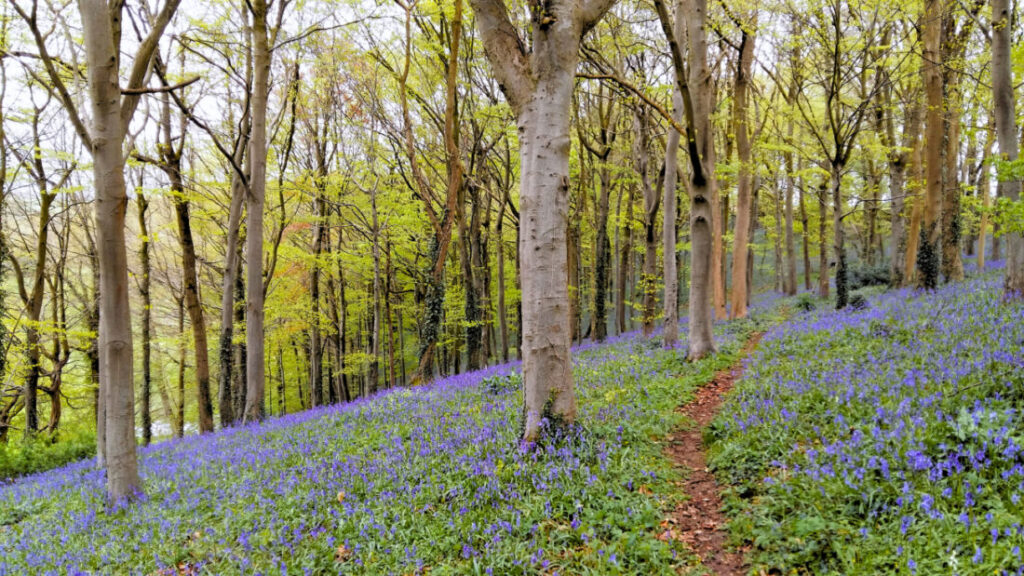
[663,334,762,576]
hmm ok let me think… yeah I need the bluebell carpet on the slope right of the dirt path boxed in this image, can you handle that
[712,270,1024,575]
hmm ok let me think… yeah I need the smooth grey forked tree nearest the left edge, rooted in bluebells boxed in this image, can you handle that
[12,0,180,503]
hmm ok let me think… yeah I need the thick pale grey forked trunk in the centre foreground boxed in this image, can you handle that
[472,0,613,442]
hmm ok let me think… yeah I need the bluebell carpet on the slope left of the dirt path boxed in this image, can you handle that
[0,319,753,575]
